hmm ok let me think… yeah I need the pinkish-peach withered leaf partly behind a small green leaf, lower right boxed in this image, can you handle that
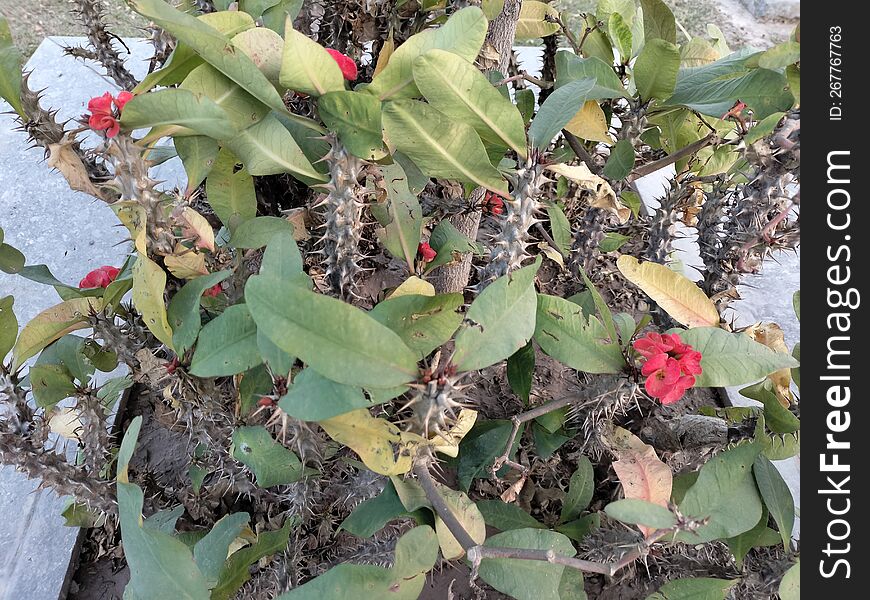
[610,427,674,535]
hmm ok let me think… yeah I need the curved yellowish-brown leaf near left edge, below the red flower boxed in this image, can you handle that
[12,298,103,371]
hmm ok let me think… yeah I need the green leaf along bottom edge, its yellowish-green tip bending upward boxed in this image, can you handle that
[276,527,438,600]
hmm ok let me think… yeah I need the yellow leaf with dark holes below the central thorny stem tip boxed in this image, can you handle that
[318,408,426,475]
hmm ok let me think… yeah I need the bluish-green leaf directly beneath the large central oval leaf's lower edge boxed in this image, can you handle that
[278,369,372,421]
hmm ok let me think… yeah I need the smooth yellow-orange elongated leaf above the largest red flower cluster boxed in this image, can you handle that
[616,254,719,328]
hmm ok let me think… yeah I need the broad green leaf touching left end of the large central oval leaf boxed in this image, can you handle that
[190,304,263,377]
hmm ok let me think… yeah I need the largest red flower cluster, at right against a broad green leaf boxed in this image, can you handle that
[634,333,701,404]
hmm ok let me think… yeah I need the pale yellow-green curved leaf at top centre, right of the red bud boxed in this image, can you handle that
[366,6,487,100]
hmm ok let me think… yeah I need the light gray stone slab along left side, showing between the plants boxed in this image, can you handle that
[0,37,179,600]
